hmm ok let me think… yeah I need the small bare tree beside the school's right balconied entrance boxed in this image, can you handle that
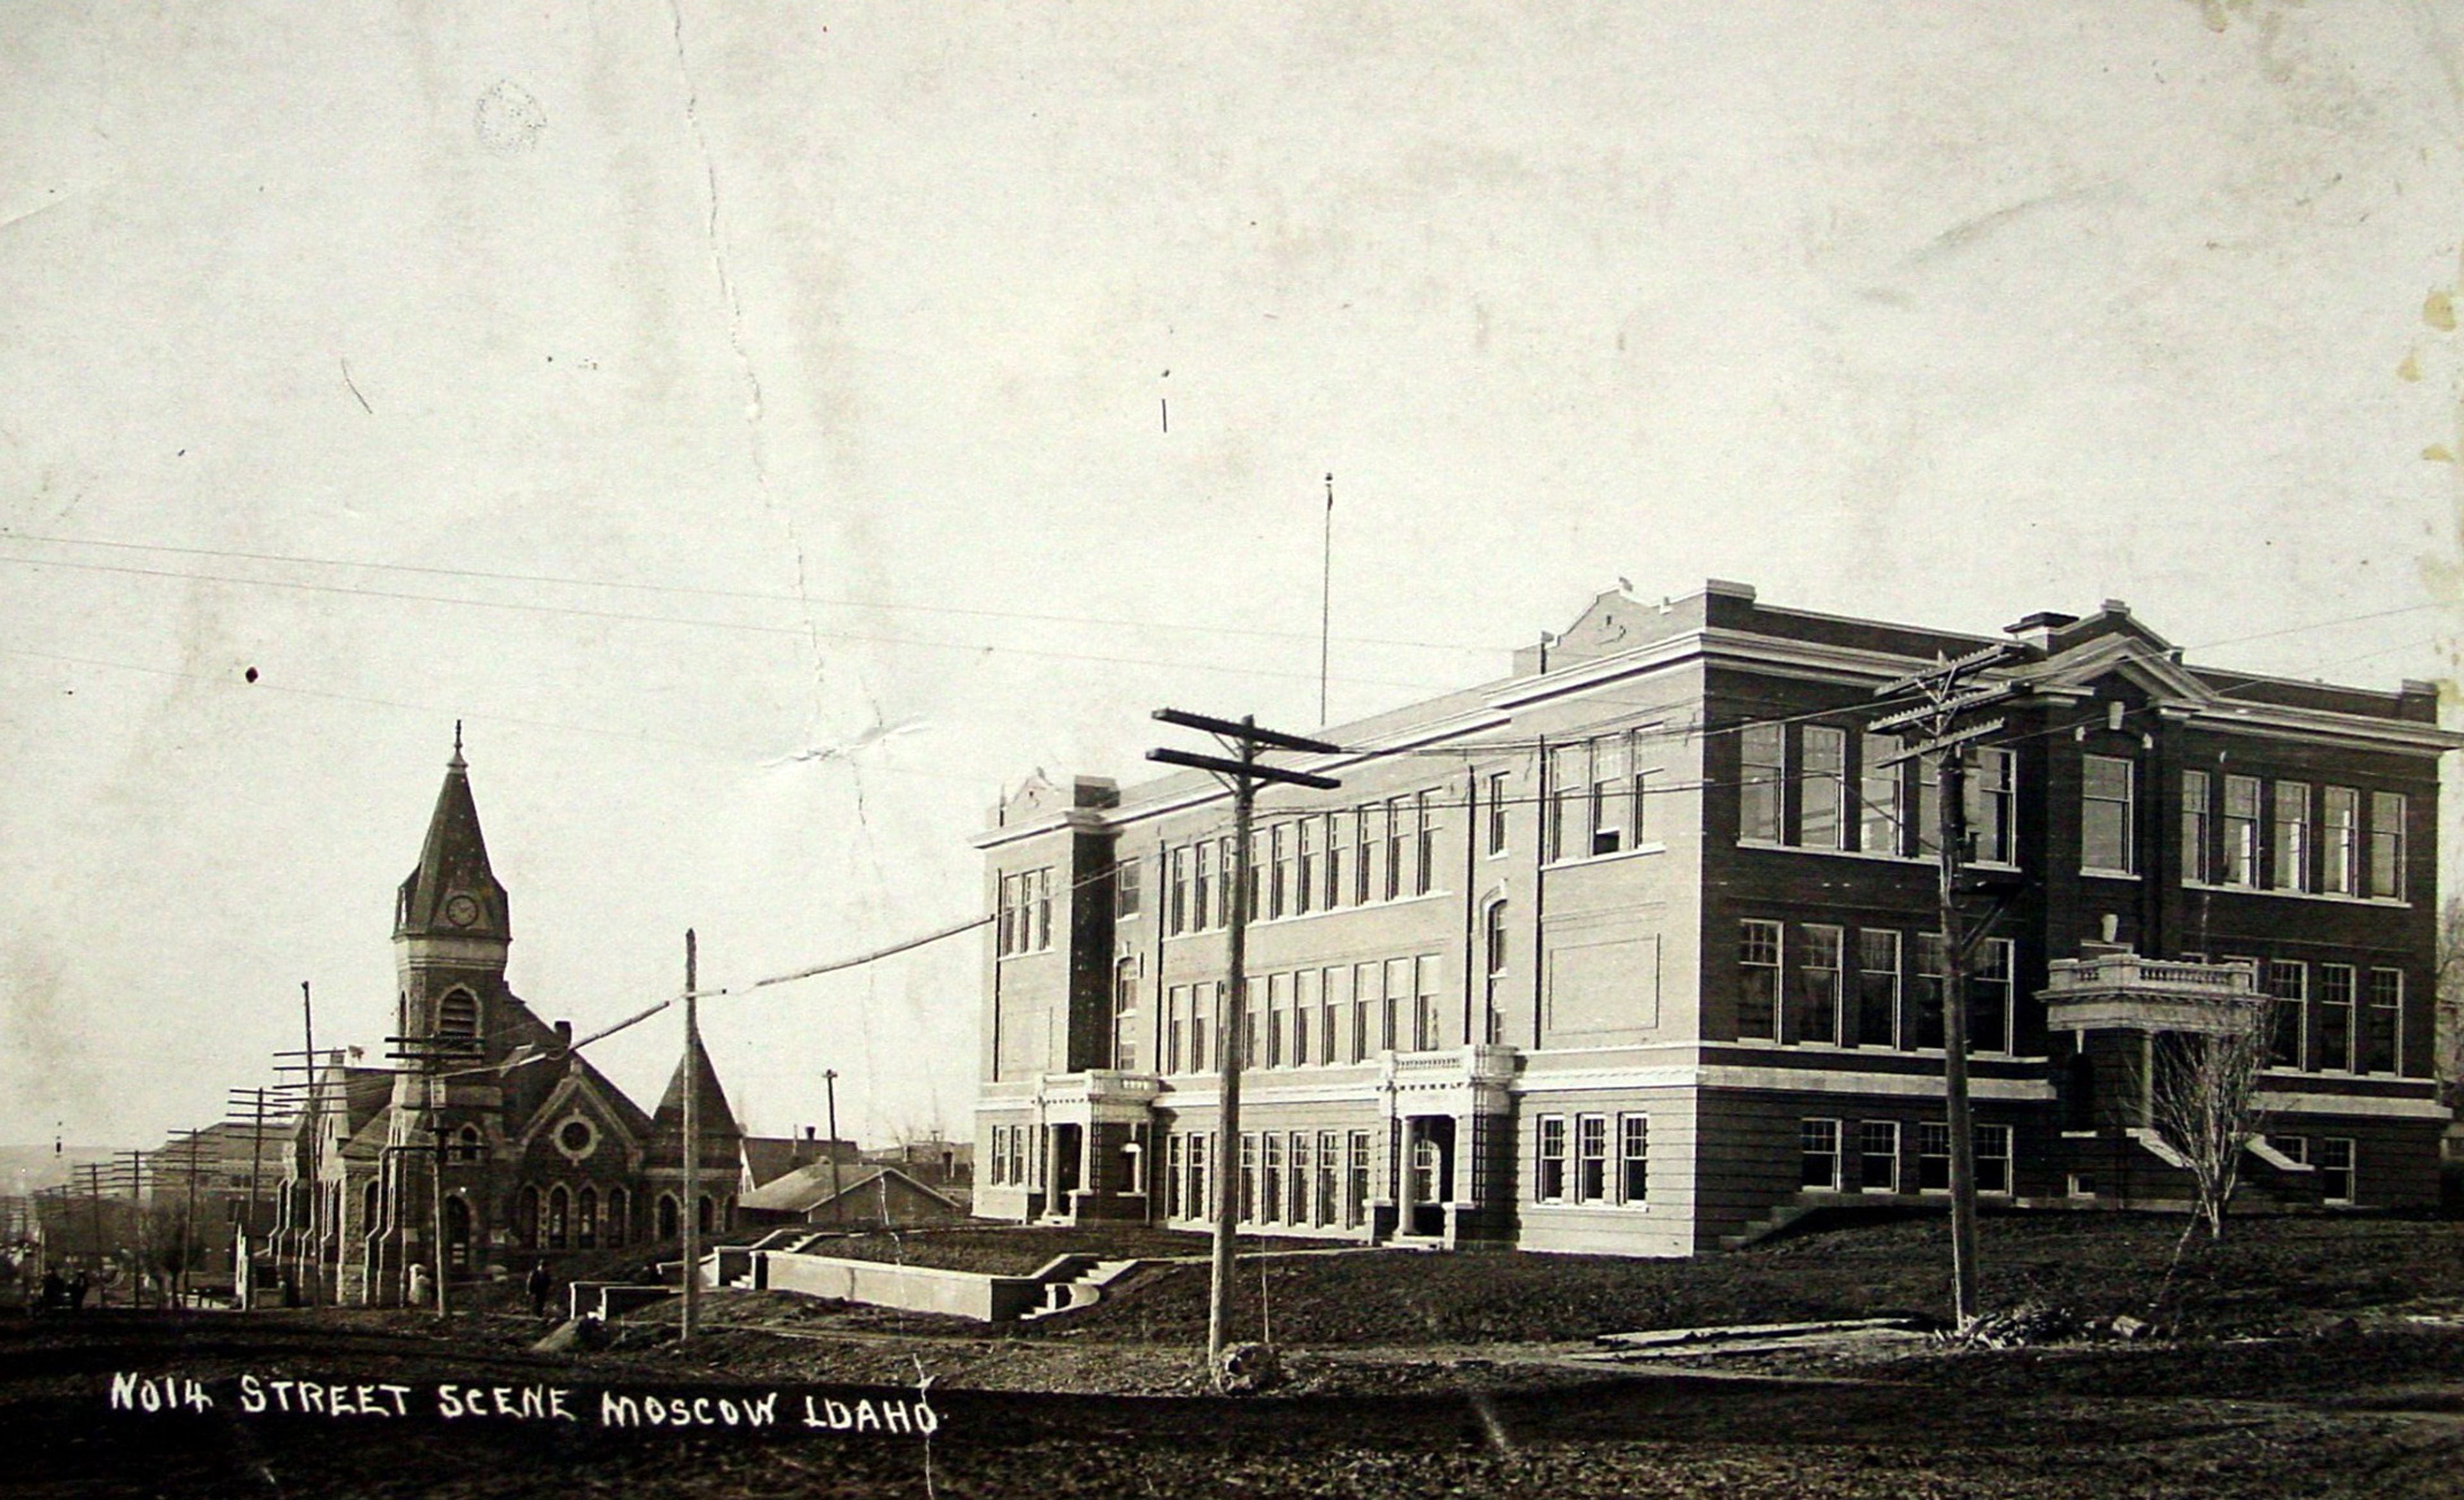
[2146,998,2270,1241]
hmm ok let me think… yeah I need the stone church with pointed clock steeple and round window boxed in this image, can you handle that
[273,724,744,1306]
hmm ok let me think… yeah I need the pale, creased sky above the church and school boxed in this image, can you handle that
[0,0,2464,1145]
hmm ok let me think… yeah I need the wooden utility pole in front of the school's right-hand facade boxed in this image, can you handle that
[1868,645,2015,1327]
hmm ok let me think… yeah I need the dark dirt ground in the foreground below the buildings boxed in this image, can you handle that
[14,1219,2464,1500]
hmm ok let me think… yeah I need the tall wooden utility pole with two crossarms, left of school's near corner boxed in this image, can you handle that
[1146,710,1343,1386]
